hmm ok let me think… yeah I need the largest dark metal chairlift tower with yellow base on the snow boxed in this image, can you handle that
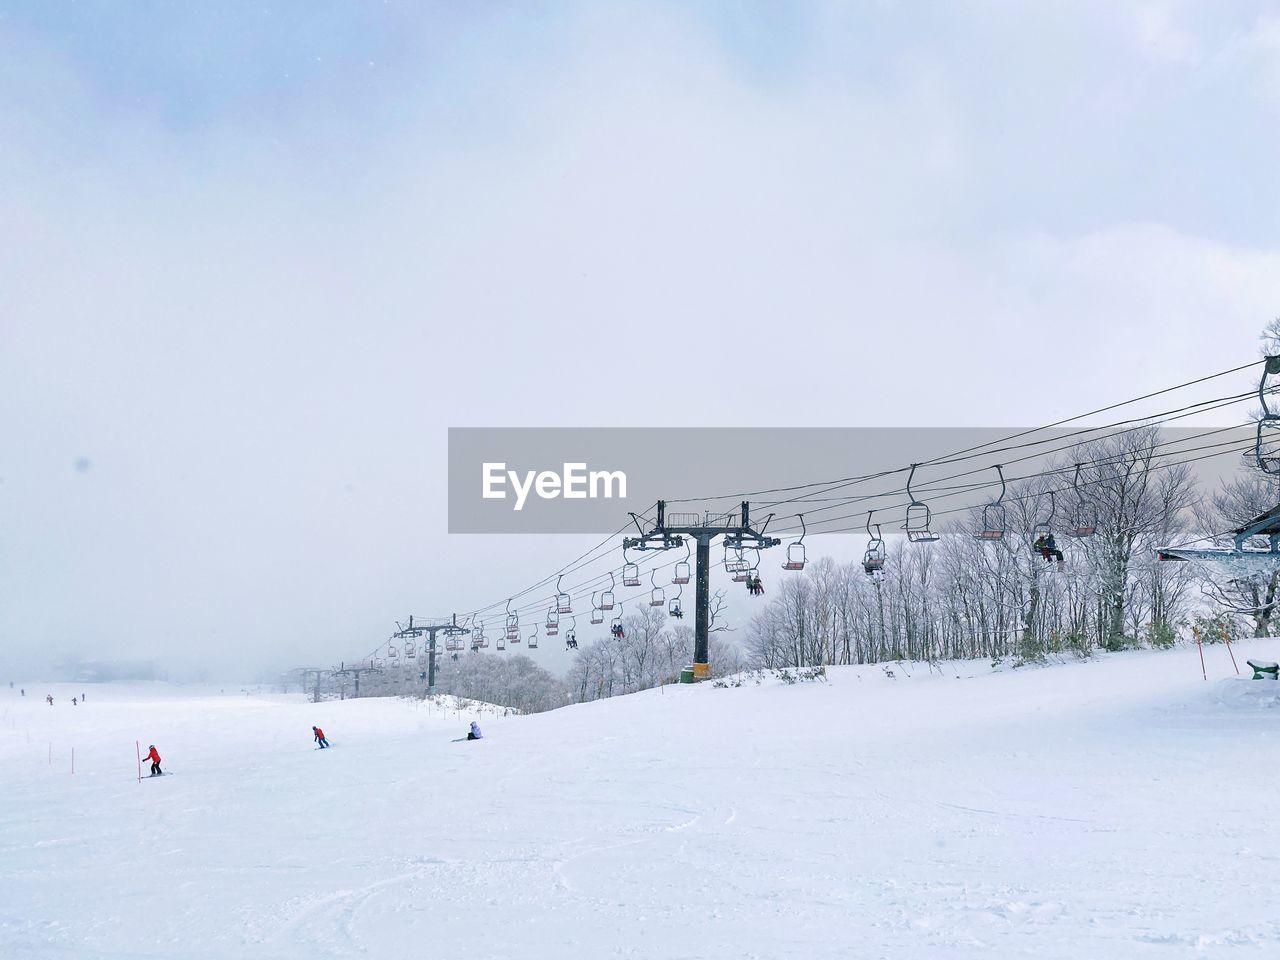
[622,500,782,681]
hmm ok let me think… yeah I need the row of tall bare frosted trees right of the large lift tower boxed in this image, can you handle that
[745,428,1280,667]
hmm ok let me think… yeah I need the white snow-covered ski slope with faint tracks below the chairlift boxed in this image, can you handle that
[0,641,1280,960]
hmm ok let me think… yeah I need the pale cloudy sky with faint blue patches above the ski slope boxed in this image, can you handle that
[0,0,1280,681]
